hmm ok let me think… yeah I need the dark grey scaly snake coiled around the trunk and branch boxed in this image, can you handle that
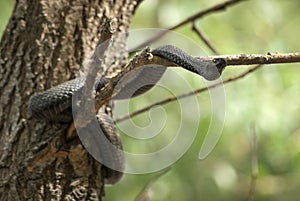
[28,45,226,184]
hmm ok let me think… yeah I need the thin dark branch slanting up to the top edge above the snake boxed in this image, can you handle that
[129,0,245,52]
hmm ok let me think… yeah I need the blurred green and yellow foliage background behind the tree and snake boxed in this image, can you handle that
[0,0,300,201]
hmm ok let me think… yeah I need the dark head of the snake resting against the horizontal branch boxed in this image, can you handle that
[202,58,226,81]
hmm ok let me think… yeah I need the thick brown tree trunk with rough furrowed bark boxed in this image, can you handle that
[0,0,139,201]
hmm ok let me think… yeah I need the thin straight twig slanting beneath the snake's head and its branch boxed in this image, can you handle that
[115,65,261,123]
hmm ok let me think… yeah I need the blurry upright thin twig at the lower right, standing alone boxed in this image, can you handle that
[246,125,258,201]
